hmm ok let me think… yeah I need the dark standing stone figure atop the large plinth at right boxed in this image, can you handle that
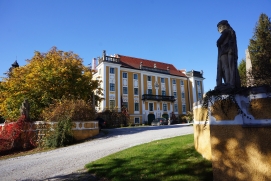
[215,20,241,91]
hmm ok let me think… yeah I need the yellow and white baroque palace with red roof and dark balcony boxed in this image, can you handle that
[92,50,204,124]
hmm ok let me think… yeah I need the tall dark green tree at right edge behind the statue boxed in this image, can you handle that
[248,14,271,86]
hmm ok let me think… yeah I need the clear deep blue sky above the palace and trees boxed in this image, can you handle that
[0,0,271,92]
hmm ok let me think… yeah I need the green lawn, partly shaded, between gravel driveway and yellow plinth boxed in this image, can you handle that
[85,134,213,181]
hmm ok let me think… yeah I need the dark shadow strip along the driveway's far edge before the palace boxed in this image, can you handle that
[89,124,193,140]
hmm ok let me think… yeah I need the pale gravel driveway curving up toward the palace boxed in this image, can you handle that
[0,124,193,181]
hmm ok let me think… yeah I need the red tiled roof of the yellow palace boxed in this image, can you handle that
[118,55,186,77]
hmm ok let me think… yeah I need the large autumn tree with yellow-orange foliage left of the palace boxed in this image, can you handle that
[0,47,102,120]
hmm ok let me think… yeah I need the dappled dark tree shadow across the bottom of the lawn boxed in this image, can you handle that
[46,147,213,181]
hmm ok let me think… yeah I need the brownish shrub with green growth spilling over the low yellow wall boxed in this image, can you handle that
[42,98,95,147]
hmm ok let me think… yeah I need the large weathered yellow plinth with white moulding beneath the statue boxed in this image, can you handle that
[194,93,271,181]
